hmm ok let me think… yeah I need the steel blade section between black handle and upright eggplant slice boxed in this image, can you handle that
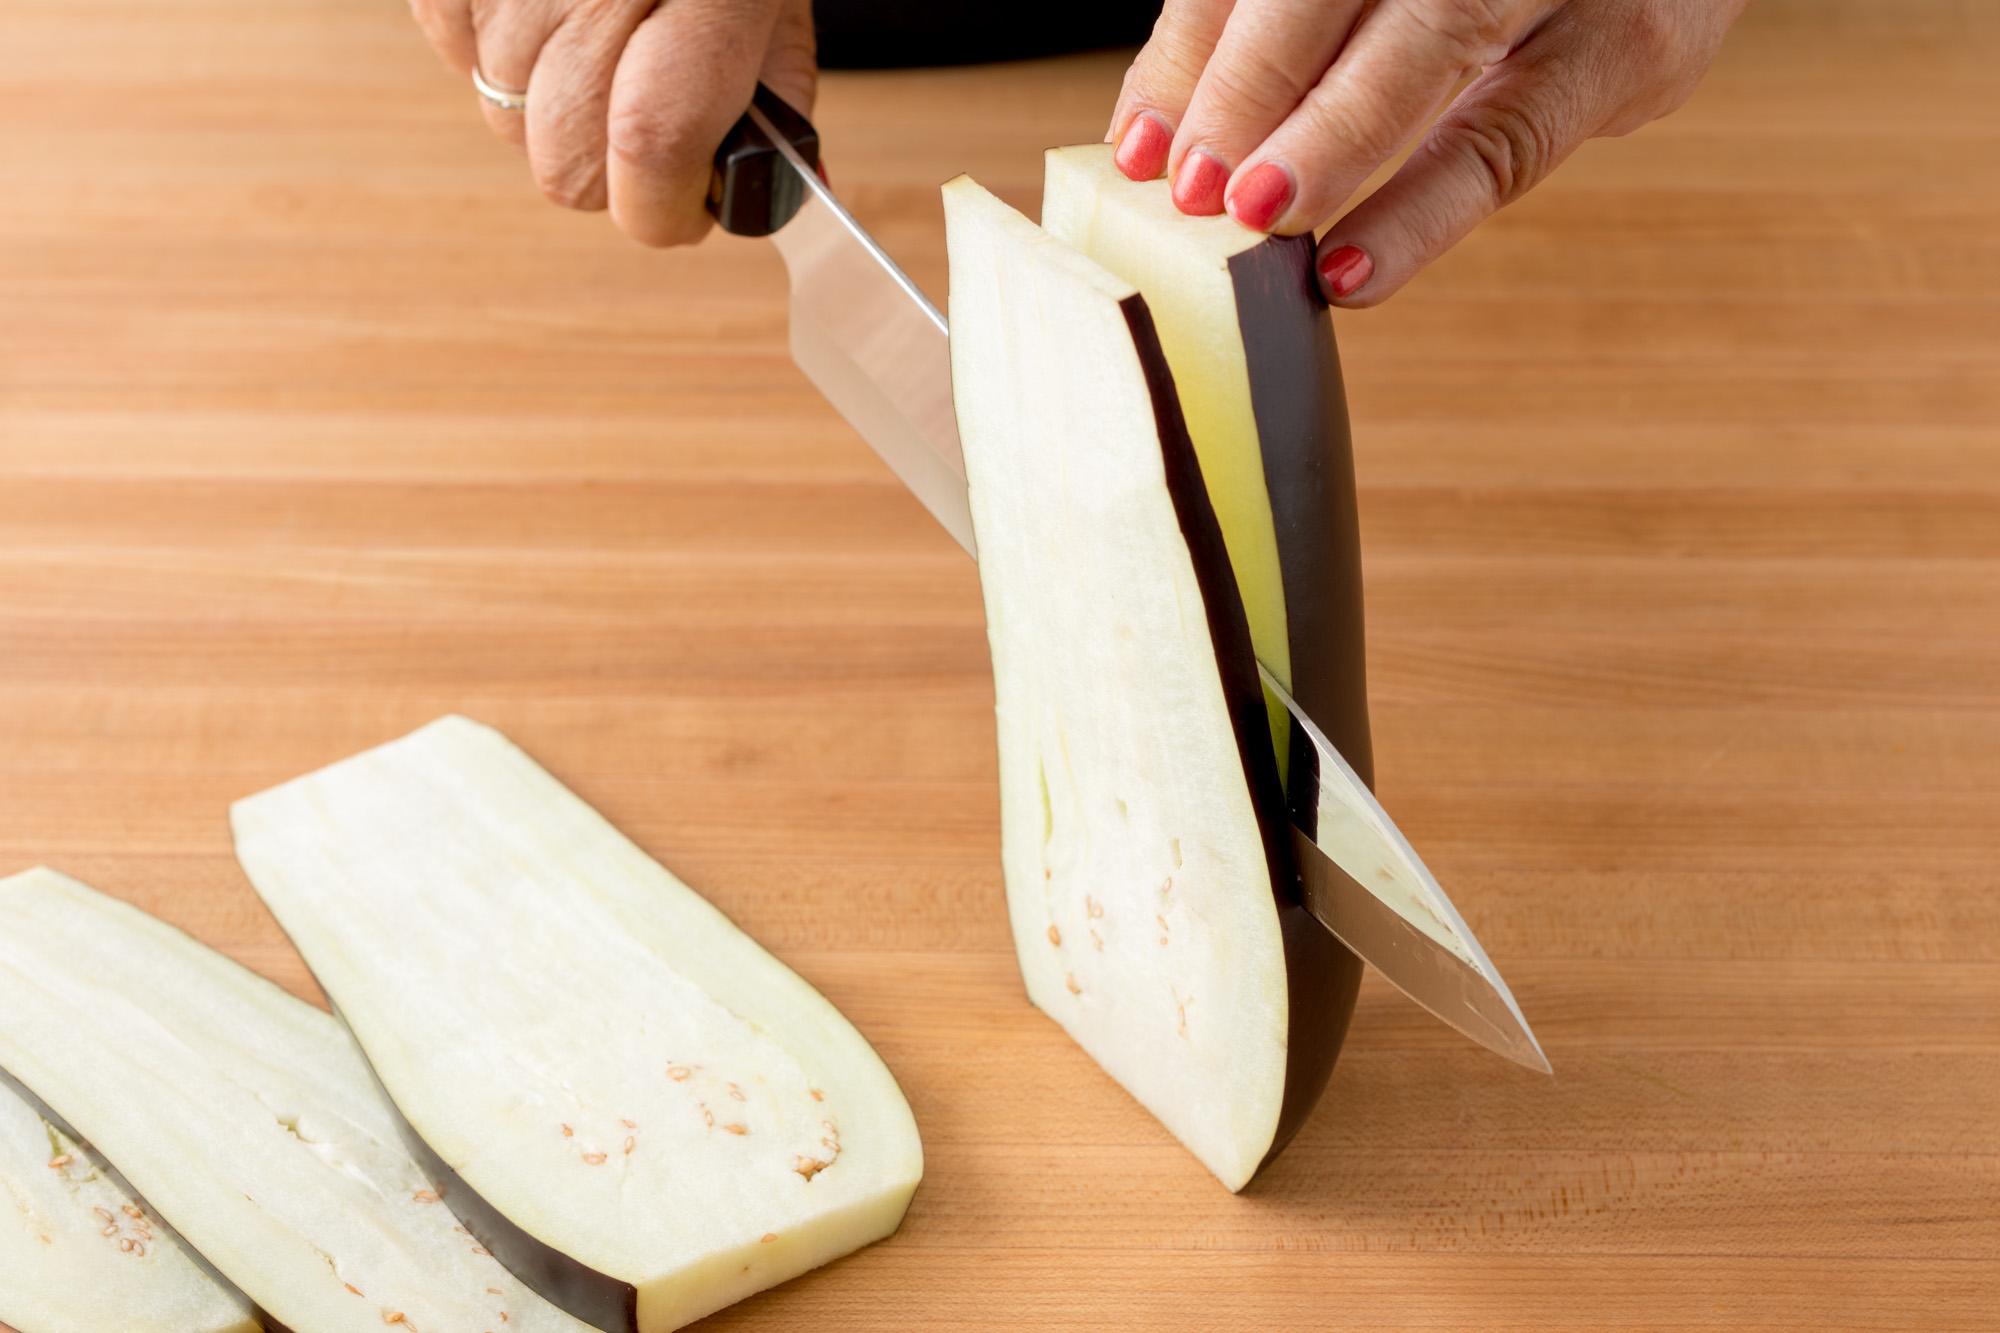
[748,106,974,550]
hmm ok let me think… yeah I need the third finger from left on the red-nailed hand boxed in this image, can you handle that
[1228,0,1554,234]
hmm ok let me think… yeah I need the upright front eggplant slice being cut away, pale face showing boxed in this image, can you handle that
[944,178,1352,1189]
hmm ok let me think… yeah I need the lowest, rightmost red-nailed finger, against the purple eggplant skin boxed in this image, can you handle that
[1318,8,1624,306]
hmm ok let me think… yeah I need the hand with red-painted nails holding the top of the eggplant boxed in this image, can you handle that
[1110,0,1746,306]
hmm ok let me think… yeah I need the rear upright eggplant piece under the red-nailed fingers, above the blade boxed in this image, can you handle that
[1042,144,1372,779]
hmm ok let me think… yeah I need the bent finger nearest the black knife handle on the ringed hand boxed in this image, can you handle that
[606,0,798,246]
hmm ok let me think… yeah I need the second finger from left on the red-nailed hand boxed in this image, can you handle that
[1168,0,1368,214]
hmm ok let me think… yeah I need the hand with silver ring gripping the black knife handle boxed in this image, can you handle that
[410,0,816,246]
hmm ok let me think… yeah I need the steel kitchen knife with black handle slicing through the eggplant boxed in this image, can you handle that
[708,84,1550,1073]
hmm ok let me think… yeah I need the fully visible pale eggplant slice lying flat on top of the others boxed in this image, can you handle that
[232,717,922,1333]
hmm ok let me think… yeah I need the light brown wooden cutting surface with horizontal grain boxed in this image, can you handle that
[0,0,2000,1329]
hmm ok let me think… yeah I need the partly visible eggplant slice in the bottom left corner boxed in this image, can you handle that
[0,1077,262,1333]
